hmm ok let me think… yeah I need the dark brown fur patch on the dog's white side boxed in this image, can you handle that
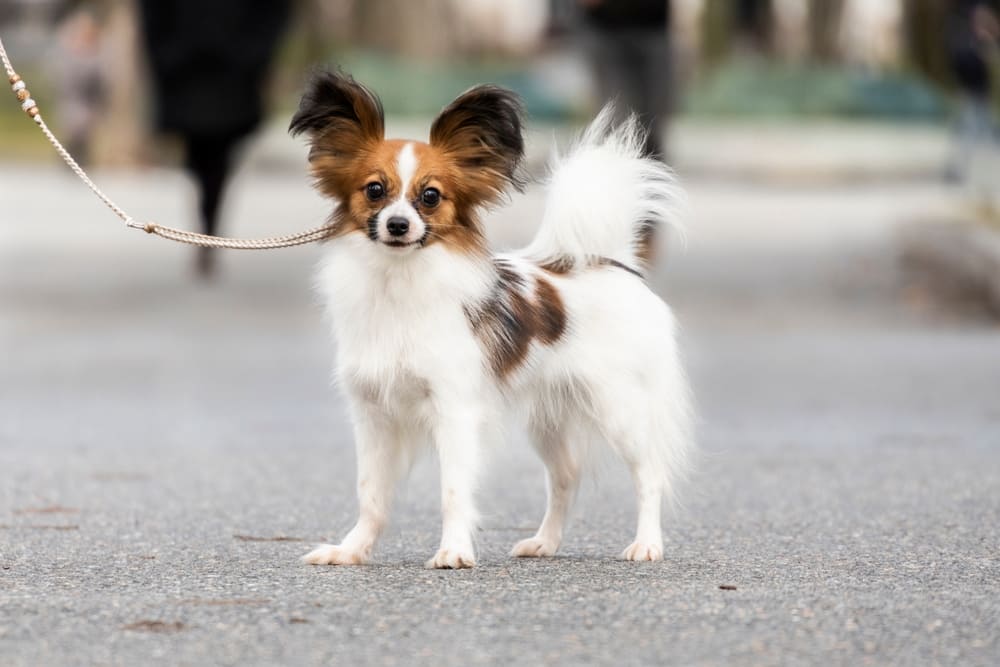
[465,260,567,378]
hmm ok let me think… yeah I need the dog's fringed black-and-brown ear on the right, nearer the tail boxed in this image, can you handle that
[431,86,525,204]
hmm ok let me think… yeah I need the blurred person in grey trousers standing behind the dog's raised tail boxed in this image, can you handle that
[577,0,672,160]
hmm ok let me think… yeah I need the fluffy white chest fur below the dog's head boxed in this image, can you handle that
[318,238,491,412]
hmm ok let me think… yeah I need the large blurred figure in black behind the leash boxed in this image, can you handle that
[139,0,289,278]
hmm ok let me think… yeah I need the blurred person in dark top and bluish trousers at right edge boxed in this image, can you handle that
[946,0,1000,187]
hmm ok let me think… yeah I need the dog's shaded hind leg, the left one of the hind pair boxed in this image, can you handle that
[511,422,580,557]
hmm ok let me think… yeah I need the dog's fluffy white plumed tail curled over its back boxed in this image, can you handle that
[526,104,687,269]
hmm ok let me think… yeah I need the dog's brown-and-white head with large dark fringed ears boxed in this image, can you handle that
[289,71,524,252]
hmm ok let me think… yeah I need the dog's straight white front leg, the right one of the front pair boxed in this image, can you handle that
[427,410,481,569]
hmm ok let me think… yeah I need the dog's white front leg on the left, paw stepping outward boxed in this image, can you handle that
[303,406,402,565]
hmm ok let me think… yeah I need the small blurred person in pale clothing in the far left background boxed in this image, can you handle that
[57,9,108,164]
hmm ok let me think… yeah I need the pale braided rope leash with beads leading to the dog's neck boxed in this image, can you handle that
[0,39,332,250]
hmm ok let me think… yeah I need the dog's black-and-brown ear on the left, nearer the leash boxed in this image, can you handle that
[288,70,385,166]
